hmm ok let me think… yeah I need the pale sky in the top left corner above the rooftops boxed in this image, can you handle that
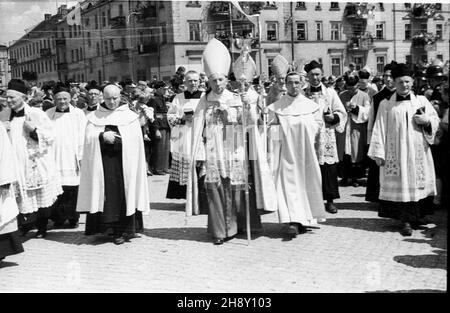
[0,0,78,45]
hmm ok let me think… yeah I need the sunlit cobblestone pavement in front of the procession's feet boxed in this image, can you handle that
[0,176,447,293]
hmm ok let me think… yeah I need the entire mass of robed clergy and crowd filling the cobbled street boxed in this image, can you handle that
[0,2,450,292]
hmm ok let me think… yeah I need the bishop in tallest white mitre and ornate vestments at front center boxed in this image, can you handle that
[186,39,274,245]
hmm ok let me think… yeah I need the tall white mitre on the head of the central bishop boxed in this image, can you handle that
[202,38,231,77]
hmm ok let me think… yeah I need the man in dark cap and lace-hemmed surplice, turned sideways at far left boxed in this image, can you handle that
[7,79,62,237]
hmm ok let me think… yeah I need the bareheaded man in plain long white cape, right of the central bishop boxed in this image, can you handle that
[268,72,325,237]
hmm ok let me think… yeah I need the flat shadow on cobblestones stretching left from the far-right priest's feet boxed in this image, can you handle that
[321,218,399,232]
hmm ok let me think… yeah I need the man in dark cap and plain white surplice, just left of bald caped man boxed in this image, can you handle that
[46,84,87,228]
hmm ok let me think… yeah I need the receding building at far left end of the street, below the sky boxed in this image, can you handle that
[9,6,67,85]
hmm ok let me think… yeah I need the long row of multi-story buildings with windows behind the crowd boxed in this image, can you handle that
[7,0,450,82]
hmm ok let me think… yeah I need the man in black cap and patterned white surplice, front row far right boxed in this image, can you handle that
[368,64,439,236]
